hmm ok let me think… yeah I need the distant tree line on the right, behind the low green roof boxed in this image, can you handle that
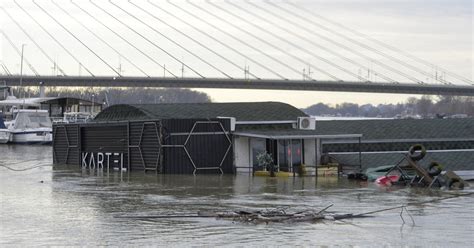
[303,96,474,118]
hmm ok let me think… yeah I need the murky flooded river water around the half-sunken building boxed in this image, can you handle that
[0,145,474,247]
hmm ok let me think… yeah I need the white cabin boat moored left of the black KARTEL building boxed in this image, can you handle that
[5,109,53,144]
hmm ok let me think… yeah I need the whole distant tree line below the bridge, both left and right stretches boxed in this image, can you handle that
[0,87,474,118]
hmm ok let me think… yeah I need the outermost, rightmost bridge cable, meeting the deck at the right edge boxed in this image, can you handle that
[285,1,474,84]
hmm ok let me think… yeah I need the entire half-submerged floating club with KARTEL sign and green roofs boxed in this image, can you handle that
[53,102,474,174]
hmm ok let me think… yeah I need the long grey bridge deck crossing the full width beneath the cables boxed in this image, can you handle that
[0,75,474,96]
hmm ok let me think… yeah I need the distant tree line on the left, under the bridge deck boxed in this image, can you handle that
[0,87,211,105]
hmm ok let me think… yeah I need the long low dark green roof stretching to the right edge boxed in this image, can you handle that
[237,118,474,142]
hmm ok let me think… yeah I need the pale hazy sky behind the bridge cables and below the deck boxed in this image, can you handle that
[0,0,473,107]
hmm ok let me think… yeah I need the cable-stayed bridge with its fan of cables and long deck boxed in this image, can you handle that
[0,0,474,96]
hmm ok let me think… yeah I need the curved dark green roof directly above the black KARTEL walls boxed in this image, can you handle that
[94,102,307,121]
